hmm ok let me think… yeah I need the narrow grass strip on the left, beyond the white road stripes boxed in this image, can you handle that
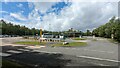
[15,41,46,45]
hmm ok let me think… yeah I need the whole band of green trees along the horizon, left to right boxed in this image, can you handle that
[0,16,120,41]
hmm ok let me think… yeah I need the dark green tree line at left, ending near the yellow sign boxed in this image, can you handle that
[0,20,39,36]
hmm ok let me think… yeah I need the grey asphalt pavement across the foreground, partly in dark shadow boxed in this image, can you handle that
[0,38,120,68]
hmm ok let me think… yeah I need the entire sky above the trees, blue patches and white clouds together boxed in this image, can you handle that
[0,1,118,31]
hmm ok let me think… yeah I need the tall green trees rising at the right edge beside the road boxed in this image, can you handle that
[92,16,120,42]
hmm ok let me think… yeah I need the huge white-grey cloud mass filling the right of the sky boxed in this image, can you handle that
[28,2,118,31]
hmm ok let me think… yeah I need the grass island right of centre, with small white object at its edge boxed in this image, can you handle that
[51,42,87,47]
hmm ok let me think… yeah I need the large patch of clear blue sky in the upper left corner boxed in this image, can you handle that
[2,2,32,17]
